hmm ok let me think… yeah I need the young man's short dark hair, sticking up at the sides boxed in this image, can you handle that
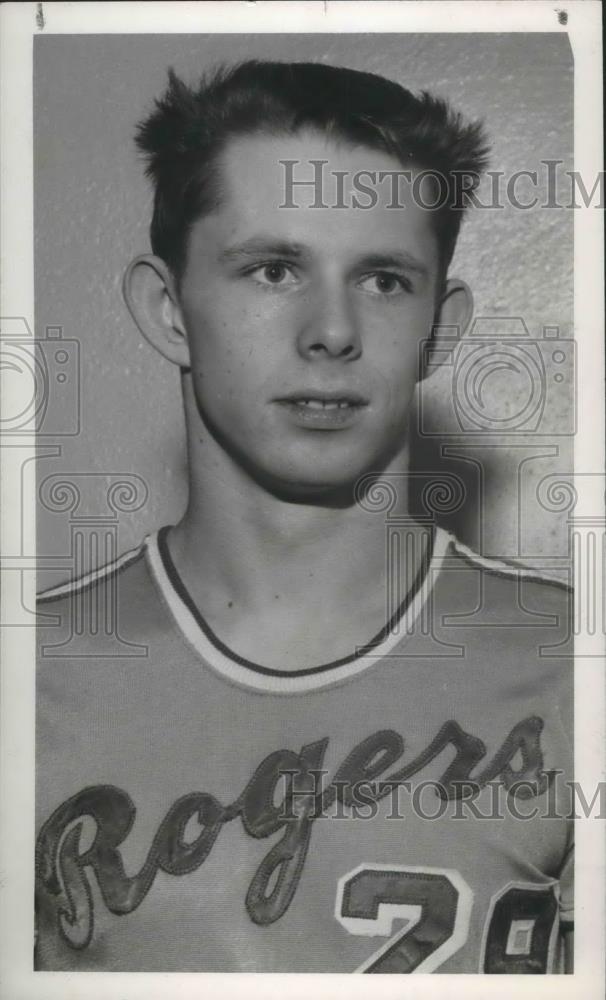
[136,60,488,281]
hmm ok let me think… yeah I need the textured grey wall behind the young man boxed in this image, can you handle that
[34,34,574,585]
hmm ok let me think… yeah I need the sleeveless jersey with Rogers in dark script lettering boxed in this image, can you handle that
[36,529,572,974]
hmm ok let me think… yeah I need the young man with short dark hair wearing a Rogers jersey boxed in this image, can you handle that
[36,62,572,973]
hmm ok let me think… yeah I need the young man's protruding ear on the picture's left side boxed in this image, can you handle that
[122,254,191,368]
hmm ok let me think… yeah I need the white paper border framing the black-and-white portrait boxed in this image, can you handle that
[0,0,606,1000]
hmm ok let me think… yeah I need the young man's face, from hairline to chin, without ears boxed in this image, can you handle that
[181,133,438,497]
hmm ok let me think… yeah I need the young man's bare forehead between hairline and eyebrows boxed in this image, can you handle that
[192,131,444,268]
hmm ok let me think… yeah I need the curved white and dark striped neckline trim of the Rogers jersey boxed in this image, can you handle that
[146,527,451,693]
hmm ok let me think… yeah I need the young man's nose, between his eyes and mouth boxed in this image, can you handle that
[297,287,362,361]
